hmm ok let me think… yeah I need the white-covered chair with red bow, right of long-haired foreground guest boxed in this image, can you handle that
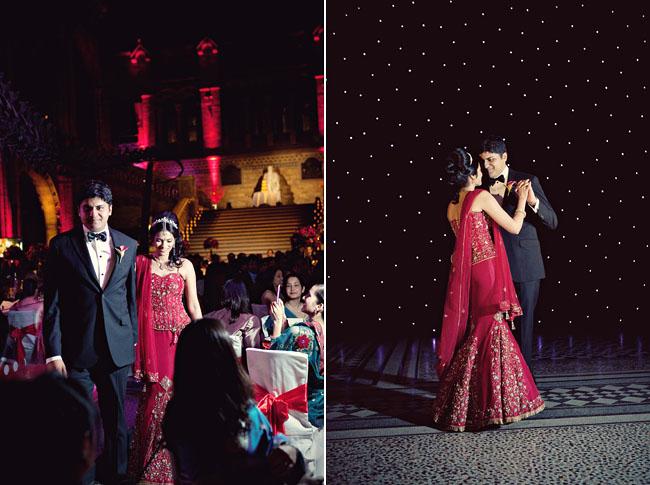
[246,348,318,469]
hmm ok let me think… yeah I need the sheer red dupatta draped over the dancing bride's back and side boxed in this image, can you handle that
[436,189,522,378]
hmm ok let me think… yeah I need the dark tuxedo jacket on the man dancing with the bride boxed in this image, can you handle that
[483,168,557,283]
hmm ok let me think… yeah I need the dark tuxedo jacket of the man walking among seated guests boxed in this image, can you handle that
[43,227,138,368]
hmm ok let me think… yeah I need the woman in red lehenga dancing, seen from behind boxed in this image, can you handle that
[433,148,544,431]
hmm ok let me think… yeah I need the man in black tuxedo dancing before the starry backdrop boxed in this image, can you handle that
[479,137,557,372]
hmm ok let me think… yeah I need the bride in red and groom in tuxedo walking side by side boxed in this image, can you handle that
[43,181,201,484]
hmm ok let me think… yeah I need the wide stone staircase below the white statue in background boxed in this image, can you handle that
[187,204,314,260]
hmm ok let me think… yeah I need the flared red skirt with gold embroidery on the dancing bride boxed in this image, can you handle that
[433,258,544,431]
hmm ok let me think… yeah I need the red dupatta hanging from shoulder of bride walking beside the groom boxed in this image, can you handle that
[133,255,159,382]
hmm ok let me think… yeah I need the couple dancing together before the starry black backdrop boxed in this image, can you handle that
[433,138,557,431]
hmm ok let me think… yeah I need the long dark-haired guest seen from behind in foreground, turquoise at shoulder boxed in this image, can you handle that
[162,318,304,484]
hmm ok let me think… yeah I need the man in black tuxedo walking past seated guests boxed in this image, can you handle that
[43,180,137,484]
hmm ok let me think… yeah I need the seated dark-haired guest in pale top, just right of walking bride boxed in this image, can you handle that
[206,279,262,361]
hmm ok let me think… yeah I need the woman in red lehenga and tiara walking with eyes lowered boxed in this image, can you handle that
[129,212,202,484]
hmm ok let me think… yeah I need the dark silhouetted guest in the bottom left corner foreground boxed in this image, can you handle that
[0,373,96,485]
